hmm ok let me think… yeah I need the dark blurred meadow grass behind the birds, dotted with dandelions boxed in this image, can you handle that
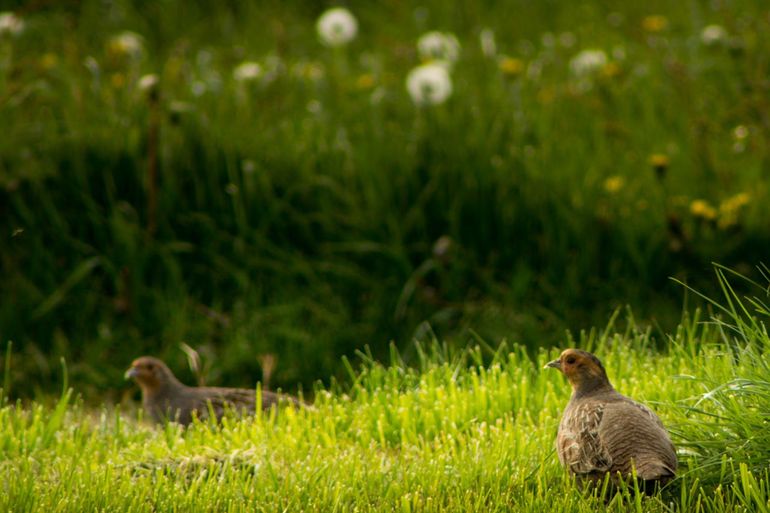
[0,0,770,395]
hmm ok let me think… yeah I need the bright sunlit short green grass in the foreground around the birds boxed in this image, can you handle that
[0,270,770,513]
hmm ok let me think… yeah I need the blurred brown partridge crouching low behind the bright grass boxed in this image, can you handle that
[125,356,301,426]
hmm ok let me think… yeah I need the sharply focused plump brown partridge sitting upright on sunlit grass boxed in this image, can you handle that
[546,349,677,489]
